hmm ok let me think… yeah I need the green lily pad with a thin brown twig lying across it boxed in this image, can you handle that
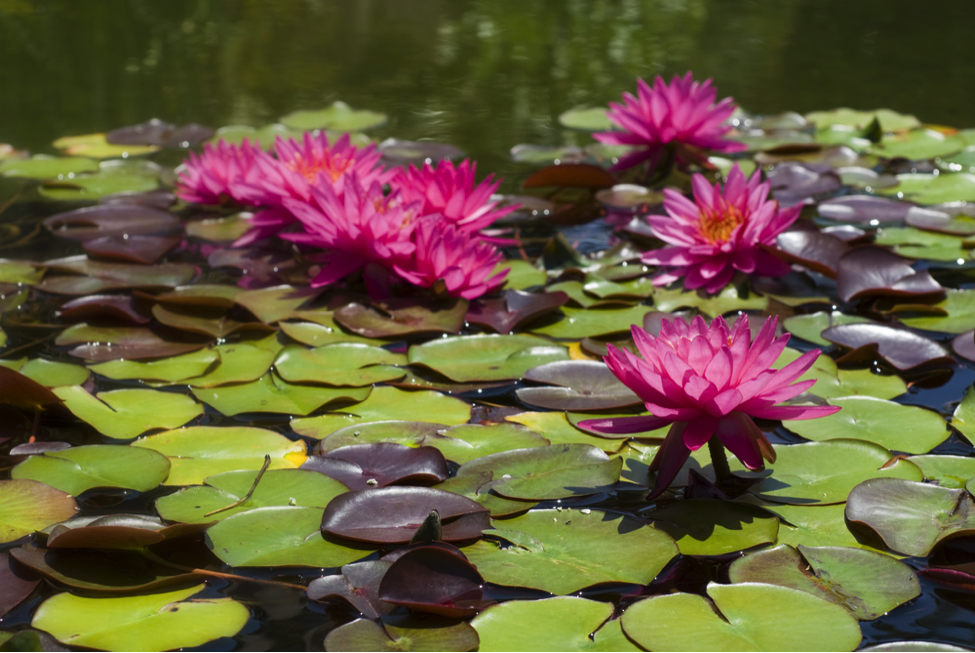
[156,469,349,524]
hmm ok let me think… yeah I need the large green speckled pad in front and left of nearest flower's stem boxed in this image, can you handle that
[462,509,677,594]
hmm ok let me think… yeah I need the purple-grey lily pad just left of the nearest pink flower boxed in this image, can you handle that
[515,360,642,411]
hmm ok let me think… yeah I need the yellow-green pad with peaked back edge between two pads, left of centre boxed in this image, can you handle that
[193,373,372,415]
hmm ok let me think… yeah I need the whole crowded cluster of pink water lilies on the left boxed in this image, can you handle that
[177,133,514,299]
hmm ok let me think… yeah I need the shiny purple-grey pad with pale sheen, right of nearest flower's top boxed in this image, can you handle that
[822,323,954,372]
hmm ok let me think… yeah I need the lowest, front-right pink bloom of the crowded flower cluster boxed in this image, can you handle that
[394,215,508,299]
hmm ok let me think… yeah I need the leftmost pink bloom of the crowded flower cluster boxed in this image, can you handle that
[176,138,264,206]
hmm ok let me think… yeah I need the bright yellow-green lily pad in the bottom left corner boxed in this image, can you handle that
[31,585,250,651]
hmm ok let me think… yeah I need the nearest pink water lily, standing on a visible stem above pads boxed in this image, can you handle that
[580,316,839,499]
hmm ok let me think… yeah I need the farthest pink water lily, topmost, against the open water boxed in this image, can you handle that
[593,72,745,170]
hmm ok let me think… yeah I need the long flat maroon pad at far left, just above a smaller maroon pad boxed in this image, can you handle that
[44,203,180,242]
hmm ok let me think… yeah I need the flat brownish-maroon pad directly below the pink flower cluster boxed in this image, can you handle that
[335,298,468,338]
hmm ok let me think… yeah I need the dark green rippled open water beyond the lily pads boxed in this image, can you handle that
[0,0,975,178]
